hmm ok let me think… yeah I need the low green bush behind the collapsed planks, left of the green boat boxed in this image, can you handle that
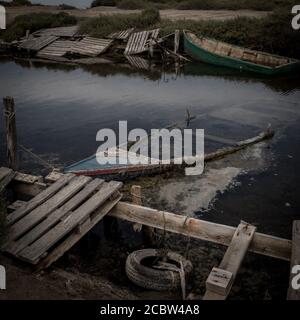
[80,9,160,37]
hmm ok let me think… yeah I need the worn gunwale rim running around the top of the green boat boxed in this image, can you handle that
[183,30,300,71]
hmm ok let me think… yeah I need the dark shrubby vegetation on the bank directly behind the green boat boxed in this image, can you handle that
[160,10,300,59]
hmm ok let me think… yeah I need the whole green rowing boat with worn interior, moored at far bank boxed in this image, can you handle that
[183,31,300,75]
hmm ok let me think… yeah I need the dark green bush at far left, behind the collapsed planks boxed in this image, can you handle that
[2,12,77,41]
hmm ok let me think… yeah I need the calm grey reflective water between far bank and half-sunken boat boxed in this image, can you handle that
[0,59,300,172]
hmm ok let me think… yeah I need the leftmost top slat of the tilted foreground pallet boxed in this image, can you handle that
[7,174,75,225]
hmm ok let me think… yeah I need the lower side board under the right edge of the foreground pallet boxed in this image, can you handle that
[38,195,122,270]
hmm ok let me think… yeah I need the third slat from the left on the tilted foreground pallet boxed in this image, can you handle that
[5,179,104,255]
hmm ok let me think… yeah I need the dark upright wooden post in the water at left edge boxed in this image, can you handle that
[3,97,19,171]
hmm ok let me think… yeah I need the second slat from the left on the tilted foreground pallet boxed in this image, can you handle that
[4,176,91,242]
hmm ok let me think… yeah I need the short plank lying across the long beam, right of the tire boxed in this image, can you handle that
[203,222,256,300]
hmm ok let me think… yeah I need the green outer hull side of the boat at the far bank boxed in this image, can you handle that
[183,32,300,75]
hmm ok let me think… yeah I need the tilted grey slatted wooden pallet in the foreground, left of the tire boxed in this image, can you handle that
[1,174,122,267]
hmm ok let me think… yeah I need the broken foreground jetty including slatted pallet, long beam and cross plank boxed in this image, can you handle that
[0,168,300,300]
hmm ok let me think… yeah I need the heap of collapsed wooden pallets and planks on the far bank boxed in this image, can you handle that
[13,26,187,70]
